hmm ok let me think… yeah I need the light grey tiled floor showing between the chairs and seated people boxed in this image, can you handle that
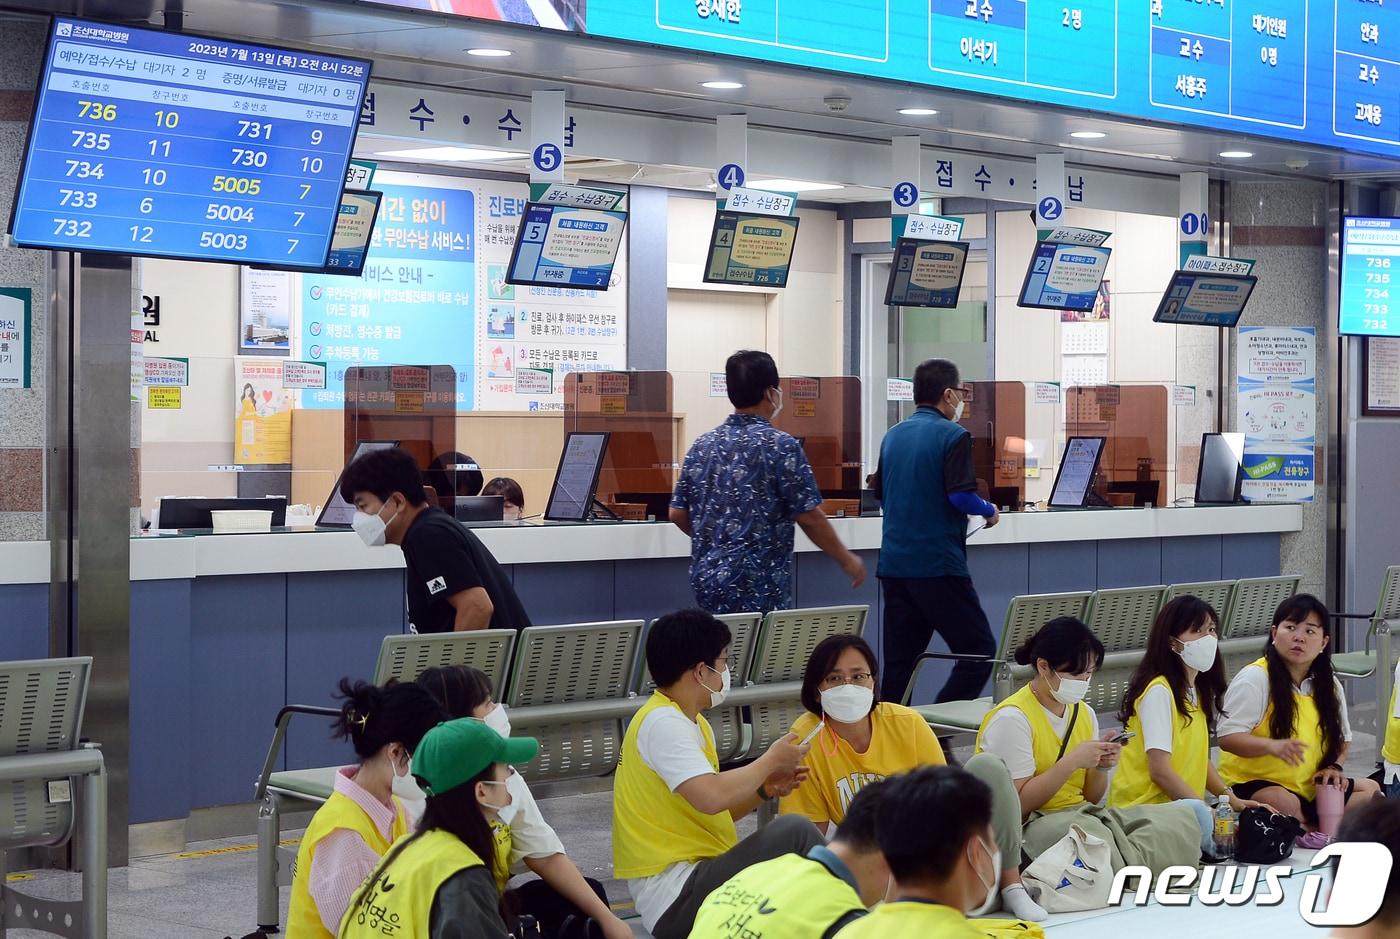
[8,733,1376,939]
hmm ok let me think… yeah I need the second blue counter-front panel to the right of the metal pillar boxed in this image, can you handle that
[189,574,287,806]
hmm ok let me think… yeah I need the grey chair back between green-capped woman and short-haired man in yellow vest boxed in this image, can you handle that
[501,620,643,782]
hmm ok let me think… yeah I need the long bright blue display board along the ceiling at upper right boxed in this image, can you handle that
[587,0,1400,157]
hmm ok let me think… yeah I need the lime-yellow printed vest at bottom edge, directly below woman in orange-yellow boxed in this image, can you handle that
[690,854,865,939]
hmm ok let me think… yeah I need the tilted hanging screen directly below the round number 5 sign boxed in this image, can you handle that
[505,203,627,290]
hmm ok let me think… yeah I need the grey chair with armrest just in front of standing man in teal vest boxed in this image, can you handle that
[902,591,1091,733]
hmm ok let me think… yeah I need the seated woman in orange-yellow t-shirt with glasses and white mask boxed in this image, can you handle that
[778,635,1046,921]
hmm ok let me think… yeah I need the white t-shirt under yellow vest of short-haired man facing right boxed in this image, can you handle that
[627,708,714,932]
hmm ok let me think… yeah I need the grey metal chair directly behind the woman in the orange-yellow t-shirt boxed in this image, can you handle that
[731,606,869,757]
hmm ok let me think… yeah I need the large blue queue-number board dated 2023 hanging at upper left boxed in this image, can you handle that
[10,18,370,270]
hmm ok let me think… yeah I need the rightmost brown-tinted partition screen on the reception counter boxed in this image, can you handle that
[1056,385,1175,505]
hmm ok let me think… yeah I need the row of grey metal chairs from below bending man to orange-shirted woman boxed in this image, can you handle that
[255,606,869,929]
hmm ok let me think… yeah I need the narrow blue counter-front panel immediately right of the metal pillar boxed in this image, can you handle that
[127,581,191,824]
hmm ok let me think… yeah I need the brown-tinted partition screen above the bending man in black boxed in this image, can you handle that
[337,365,459,511]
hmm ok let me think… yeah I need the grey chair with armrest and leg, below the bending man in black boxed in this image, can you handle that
[253,630,517,932]
